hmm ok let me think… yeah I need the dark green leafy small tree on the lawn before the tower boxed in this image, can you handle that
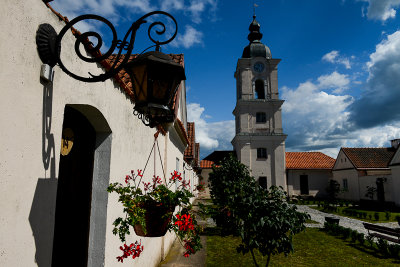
[210,157,309,266]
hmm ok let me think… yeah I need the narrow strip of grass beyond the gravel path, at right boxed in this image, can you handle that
[310,206,400,223]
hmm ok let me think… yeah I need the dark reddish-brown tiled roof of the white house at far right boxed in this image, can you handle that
[341,147,395,169]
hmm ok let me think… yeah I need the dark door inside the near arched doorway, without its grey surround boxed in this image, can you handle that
[52,107,96,267]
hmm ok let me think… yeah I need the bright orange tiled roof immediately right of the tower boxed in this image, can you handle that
[285,152,335,169]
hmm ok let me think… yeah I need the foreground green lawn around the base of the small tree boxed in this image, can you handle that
[206,228,400,267]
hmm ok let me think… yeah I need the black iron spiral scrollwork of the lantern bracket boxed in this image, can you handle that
[54,11,178,82]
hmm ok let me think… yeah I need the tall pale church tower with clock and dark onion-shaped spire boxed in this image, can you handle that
[232,16,287,190]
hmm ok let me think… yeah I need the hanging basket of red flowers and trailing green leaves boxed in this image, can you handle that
[107,170,202,262]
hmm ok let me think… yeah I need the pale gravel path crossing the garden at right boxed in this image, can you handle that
[297,205,399,234]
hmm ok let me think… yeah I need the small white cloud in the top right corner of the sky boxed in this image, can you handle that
[363,0,400,22]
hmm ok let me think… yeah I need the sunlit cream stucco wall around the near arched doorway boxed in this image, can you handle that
[0,0,197,266]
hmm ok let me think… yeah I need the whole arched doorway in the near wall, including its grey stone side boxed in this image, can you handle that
[52,105,111,267]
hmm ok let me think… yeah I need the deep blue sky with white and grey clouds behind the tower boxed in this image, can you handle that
[50,0,400,157]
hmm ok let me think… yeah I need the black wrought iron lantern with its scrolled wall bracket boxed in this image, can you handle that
[36,11,186,127]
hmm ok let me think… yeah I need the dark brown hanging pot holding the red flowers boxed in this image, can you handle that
[134,203,175,237]
